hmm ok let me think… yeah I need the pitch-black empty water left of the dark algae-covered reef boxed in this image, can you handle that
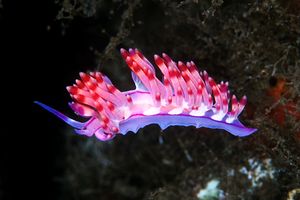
[0,1,78,199]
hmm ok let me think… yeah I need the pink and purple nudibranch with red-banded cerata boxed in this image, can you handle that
[35,49,257,141]
